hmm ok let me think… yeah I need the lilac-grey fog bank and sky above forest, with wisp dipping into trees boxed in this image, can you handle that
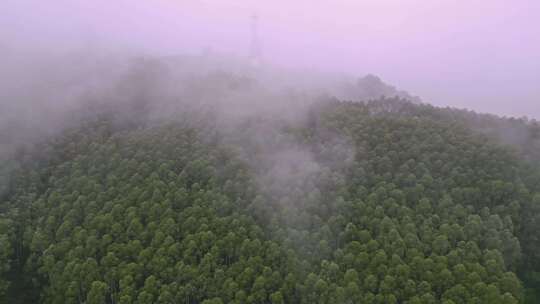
[0,0,540,195]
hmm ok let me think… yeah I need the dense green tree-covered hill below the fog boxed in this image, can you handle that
[0,99,540,304]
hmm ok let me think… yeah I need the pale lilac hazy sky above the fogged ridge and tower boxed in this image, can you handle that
[0,0,540,118]
